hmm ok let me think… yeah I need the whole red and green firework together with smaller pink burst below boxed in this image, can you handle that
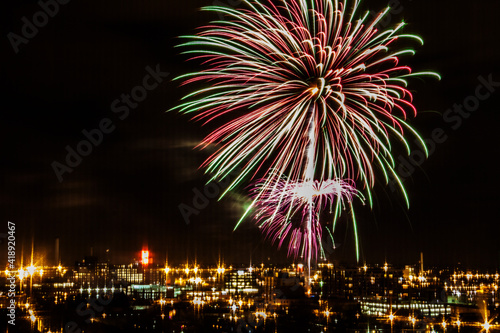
[175,0,438,259]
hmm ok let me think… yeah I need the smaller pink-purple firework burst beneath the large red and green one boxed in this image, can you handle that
[253,179,359,258]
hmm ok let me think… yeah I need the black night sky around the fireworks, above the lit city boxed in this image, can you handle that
[0,0,500,269]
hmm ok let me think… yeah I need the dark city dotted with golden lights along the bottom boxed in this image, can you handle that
[0,251,500,333]
